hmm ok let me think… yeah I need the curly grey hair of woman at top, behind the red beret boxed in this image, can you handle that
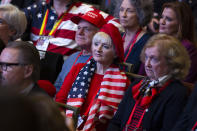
[114,0,153,27]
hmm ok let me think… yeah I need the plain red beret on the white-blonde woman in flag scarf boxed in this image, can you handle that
[99,23,124,62]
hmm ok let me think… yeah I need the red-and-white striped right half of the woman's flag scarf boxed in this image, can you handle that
[83,67,128,131]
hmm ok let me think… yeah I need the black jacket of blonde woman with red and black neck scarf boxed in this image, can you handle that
[108,81,187,131]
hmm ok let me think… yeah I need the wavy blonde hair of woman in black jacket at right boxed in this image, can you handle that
[141,34,191,80]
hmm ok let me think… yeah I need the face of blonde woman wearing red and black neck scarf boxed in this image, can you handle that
[144,46,169,80]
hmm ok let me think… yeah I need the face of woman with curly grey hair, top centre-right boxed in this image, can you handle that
[119,0,139,28]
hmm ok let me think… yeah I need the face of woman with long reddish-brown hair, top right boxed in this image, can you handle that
[159,8,179,37]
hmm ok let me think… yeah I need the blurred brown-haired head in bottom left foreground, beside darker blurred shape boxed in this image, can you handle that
[29,93,68,131]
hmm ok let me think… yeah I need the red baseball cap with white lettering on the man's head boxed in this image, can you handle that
[71,10,106,28]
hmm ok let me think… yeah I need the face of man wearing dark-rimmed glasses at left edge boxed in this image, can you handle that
[0,48,25,88]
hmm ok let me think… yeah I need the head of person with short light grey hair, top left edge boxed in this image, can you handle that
[0,4,27,45]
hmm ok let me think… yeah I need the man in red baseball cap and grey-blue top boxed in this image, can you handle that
[55,11,105,91]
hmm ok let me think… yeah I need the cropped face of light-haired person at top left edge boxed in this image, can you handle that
[0,12,14,44]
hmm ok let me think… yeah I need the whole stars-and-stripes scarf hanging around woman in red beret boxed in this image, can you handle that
[66,59,128,131]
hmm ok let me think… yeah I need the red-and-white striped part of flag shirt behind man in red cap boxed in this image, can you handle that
[30,2,122,56]
